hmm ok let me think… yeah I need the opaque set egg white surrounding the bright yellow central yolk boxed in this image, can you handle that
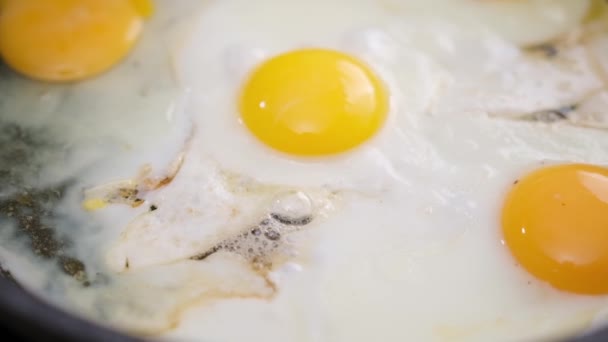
[1,0,608,341]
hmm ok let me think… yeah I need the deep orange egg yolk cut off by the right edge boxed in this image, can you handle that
[502,164,608,294]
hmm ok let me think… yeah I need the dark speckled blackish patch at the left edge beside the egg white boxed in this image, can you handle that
[0,122,86,282]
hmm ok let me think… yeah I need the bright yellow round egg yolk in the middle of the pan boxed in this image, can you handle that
[240,49,388,156]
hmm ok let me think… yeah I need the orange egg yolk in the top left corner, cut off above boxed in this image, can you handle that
[0,0,152,82]
